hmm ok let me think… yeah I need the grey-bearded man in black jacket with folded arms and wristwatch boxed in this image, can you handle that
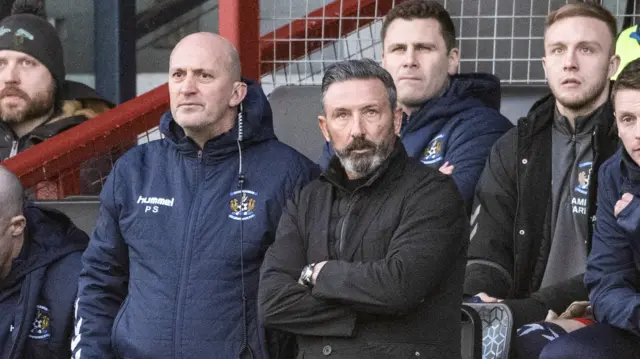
[259,60,468,359]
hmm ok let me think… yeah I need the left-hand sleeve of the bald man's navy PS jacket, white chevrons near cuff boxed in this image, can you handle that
[71,165,129,359]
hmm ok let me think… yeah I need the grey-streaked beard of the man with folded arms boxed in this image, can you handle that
[330,126,396,179]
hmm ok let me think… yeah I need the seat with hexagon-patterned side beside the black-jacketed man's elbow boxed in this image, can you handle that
[465,303,513,359]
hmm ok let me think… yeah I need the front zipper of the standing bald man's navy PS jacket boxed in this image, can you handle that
[173,150,205,359]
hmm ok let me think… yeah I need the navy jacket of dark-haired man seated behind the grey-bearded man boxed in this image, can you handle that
[320,73,513,204]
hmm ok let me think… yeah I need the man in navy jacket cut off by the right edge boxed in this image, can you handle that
[541,60,640,359]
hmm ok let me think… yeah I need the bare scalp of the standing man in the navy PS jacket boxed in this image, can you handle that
[170,32,242,81]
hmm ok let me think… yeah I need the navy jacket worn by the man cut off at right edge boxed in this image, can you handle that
[584,148,640,334]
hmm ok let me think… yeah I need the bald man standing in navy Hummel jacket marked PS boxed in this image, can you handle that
[72,33,317,359]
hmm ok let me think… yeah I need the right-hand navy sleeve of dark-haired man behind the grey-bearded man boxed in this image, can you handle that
[442,110,513,205]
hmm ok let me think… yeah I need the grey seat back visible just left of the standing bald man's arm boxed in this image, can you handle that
[35,196,100,235]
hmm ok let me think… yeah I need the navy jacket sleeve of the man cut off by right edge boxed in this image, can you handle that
[585,170,640,332]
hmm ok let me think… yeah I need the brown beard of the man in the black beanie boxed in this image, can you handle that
[0,87,55,124]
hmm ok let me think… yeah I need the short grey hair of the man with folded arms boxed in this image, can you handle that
[322,59,398,112]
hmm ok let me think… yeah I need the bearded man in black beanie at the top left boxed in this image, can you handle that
[0,0,111,161]
